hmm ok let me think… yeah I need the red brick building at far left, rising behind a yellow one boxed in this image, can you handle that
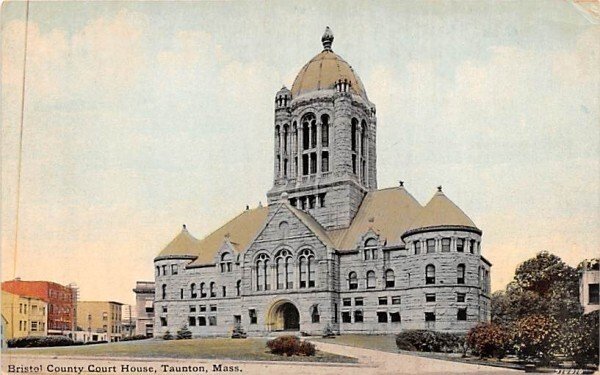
[2,279,77,335]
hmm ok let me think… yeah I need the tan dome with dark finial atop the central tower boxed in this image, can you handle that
[292,27,368,100]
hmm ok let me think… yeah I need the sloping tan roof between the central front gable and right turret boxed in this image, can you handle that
[329,187,423,250]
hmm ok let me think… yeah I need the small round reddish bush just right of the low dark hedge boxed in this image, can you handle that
[467,323,510,359]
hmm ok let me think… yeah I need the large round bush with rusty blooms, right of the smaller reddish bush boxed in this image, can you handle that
[513,315,559,364]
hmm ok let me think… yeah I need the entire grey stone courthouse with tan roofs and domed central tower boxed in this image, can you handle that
[154,28,491,337]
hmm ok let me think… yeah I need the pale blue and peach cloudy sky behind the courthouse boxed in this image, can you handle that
[1,0,600,303]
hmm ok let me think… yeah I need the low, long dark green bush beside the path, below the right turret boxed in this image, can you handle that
[396,329,465,353]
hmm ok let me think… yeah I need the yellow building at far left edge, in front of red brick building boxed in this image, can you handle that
[2,290,48,339]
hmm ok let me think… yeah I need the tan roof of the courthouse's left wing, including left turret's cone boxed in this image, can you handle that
[158,207,269,265]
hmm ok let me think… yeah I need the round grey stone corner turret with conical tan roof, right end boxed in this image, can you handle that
[402,186,491,331]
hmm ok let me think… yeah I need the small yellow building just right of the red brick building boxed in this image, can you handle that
[77,301,123,342]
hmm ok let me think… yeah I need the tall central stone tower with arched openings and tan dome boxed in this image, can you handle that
[267,27,377,229]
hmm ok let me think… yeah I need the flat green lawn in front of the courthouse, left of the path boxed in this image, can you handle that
[3,338,357,363]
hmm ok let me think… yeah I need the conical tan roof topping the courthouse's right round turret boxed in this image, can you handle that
[410,190,477,229]
